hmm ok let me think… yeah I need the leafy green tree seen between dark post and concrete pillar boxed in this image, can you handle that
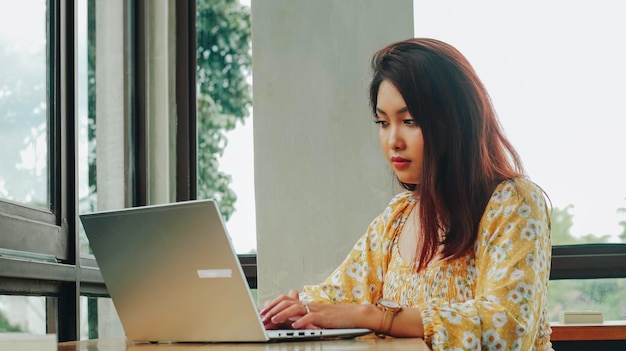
[196,0,252,219]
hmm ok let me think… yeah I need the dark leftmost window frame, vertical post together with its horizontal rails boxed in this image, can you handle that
[0,0,80,341]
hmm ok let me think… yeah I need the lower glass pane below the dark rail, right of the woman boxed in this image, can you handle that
[548,278,626,322]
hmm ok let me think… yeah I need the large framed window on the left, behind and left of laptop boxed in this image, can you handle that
[0,0,200,341]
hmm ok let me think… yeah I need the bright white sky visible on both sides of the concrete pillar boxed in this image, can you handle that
[221,0,626,253]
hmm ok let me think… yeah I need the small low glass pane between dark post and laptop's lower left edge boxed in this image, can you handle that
[80,296,125,340]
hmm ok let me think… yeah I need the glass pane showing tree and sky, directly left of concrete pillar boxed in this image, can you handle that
[196,0,256,254]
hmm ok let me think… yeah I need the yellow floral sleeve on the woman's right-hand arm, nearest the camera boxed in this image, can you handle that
[420,180,551,350]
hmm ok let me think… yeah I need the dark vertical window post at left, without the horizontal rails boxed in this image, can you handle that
[52,0,80,341]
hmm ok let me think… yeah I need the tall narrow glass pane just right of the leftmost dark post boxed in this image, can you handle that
[76,0,97,255]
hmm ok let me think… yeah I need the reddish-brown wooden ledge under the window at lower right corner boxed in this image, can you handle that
[550,320,626,341]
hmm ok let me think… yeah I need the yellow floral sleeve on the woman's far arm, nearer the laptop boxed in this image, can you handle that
[300,193,410,304]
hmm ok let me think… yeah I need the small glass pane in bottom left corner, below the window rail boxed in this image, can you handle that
[0,295,46,335]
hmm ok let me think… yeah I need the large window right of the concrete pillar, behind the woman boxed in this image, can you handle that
[414,0,626,320]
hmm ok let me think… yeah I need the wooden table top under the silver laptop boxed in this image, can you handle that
[58,335,430,351]
